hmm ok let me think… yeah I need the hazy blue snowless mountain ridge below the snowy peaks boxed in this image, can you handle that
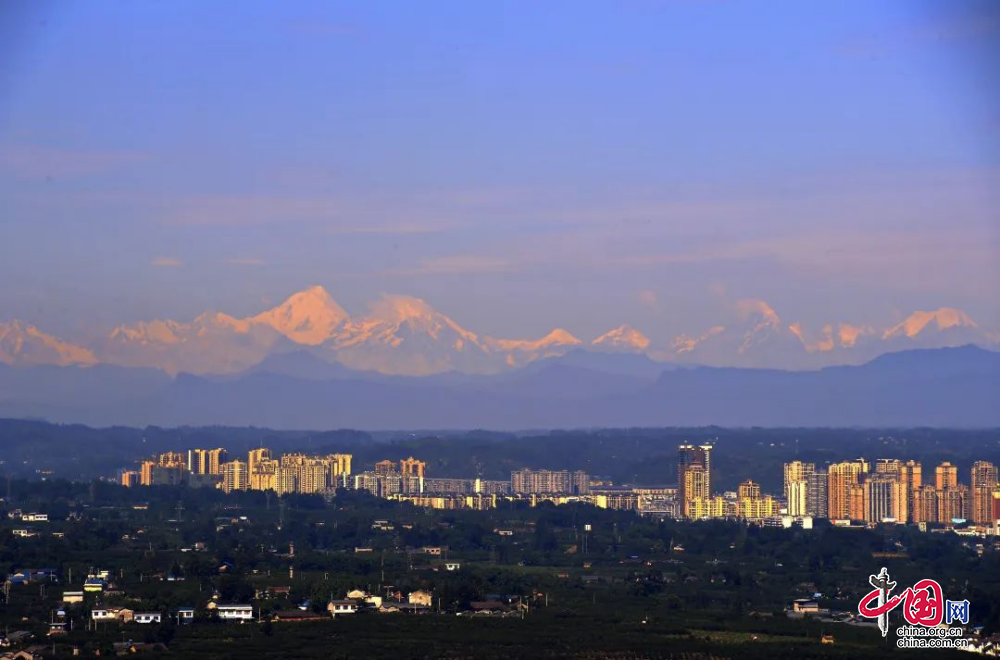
[0,346,1000,430]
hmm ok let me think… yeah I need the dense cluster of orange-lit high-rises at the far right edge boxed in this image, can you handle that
[785,458,1000,525]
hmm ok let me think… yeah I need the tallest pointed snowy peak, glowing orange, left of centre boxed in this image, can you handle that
[252,286,350,346]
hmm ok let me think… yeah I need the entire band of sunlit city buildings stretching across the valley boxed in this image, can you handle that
[121,444,1000,526]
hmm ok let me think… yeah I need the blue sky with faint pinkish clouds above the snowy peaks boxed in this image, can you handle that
[0,0,1000,338]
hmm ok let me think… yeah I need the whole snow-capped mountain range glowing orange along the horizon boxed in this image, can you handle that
[0,286,1000,376]
